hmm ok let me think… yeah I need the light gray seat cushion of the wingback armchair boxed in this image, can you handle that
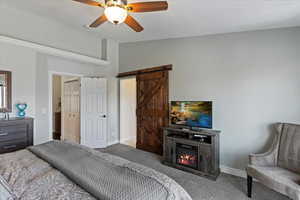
[247,165,300,200]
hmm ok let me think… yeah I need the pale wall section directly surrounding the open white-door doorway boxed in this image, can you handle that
[35,41,119,143]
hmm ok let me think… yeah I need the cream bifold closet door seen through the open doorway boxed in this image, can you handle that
[62,80,80,143]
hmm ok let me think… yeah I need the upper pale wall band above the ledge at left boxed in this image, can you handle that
[0,1,101,57]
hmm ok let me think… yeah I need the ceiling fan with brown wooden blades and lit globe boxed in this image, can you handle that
[73,0,168,32]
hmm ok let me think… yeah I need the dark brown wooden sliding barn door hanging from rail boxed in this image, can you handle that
[137,71,169,155]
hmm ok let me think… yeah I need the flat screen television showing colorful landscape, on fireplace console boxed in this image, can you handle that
[170,101,213,129]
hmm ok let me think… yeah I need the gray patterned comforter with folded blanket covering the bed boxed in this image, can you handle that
[0,141,191,200]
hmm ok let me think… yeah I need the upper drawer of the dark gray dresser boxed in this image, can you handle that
[0,124,27,142]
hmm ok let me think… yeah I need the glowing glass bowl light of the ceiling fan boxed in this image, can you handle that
[104,6,128,24]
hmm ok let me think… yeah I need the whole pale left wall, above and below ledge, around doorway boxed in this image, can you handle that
[0,1,119,144]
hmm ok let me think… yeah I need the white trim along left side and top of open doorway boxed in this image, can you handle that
[48,71,84,141]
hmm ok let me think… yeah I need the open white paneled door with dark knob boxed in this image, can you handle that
[81,78,107,148]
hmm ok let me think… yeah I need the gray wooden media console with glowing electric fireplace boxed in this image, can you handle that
[163,127,220,180]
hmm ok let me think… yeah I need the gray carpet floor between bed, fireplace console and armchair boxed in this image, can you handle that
[100,144,289,200]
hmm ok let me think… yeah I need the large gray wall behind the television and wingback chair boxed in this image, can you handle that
[119,28,300,169]
